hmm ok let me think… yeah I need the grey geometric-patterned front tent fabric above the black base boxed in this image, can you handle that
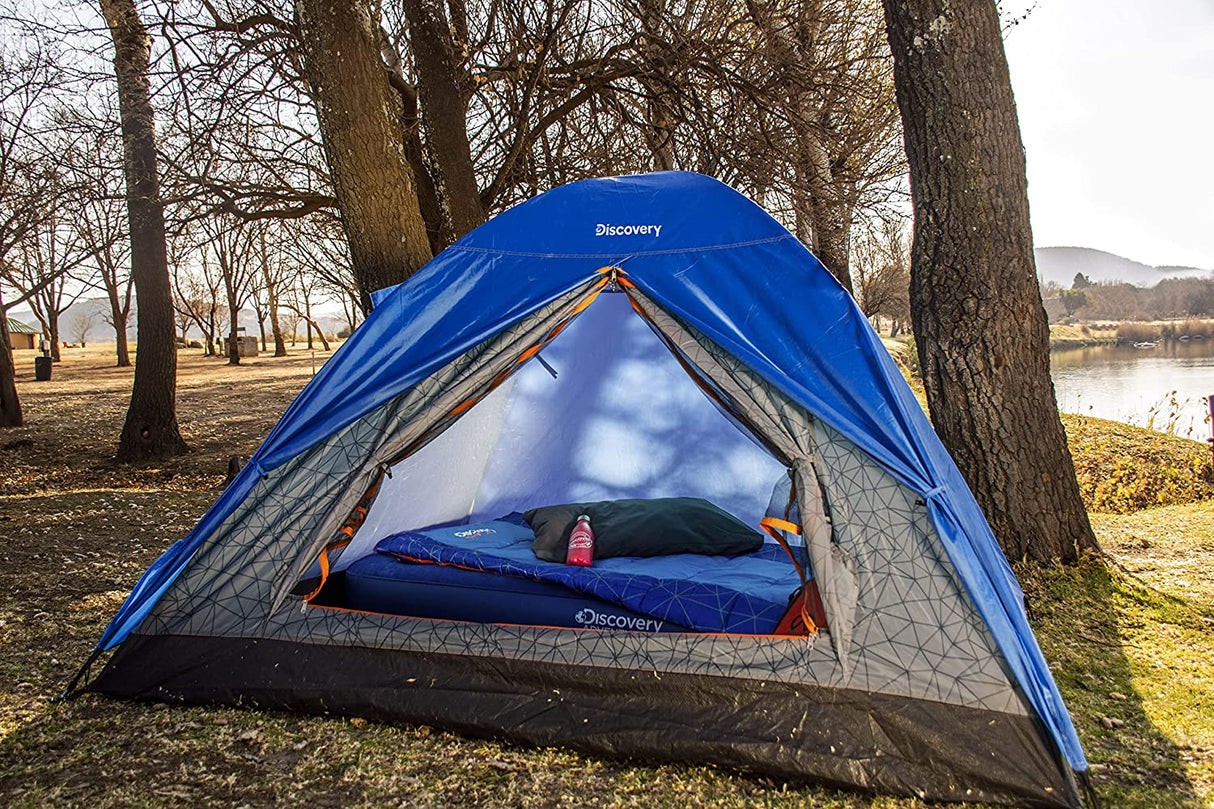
[140,288,1028,714]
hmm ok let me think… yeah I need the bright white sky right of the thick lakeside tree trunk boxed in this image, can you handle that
[1004,0,1214,270]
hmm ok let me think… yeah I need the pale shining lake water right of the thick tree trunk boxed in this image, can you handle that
[1050,340,1214,441]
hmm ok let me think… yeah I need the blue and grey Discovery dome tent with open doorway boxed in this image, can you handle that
[69,172,1090,807]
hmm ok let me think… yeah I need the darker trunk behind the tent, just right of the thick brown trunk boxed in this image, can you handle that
[403,0,484,238]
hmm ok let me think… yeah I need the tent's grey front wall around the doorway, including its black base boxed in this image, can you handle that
[91,281,1078,805]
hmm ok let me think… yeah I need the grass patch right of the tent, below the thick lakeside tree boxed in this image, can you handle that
[1017,504,1214,807]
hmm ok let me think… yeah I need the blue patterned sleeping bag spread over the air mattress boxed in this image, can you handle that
[375,514,800,634]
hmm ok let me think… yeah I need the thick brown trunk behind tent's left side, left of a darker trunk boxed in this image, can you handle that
[295,0,432,311]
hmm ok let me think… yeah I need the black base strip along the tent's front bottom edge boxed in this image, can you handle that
[89,635,1080,807]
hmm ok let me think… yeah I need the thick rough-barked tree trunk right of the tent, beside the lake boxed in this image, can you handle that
[884,0,1096,562]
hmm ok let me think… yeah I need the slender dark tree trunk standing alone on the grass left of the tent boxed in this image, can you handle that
[101,0,188,462]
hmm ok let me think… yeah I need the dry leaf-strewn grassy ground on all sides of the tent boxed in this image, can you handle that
[0,349,1214,809]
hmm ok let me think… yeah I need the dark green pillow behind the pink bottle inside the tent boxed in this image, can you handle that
[523,497,764,562]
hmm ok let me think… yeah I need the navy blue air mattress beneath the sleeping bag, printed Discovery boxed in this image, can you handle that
[344,554,687,632]
